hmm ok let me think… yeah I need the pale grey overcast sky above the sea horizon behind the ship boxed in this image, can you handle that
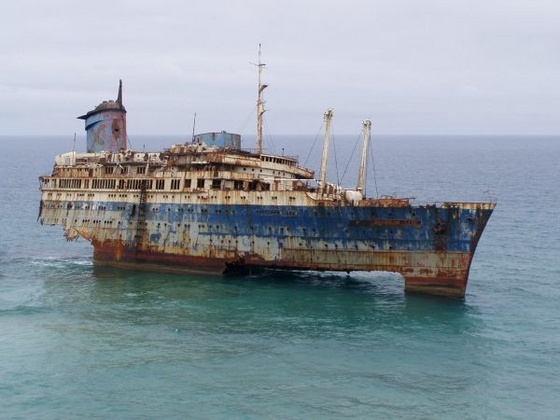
[0,0,560,136]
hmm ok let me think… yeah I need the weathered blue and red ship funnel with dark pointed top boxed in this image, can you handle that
[78,80,127,153]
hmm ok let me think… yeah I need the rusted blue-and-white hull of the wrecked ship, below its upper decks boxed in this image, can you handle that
[41,192,493,297]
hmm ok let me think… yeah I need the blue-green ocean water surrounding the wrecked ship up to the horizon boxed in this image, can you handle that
[0,136,560,419]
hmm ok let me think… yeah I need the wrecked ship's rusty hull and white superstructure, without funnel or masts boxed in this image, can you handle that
[39,83,495,297]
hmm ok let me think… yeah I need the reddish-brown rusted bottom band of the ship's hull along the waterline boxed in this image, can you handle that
[93,242,482,298]
